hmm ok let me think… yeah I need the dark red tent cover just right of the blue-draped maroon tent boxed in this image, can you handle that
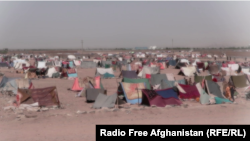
[179,84,200,99]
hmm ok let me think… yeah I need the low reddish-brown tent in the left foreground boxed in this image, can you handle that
[16,86,60,111]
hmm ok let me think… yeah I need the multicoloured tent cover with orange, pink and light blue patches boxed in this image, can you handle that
[120,82,146,104]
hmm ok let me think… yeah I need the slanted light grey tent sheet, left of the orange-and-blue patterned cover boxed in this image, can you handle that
[93,93,118,109]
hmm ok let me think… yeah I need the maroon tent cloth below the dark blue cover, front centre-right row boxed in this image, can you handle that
[141,89,182,107]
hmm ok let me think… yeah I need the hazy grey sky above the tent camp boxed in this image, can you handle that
[0,0,250,49]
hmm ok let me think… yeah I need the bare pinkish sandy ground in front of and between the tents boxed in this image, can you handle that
[0,55,250,141]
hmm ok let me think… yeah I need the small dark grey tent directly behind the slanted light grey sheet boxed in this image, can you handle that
[86,88,107,102]
